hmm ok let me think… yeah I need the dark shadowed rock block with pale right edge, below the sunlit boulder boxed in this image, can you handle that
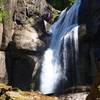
[9,51,39,90]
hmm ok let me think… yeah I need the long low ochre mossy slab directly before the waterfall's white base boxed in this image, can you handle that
[0,91,59,100]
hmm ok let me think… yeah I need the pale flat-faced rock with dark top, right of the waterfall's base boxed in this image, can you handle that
[60,86,90,100]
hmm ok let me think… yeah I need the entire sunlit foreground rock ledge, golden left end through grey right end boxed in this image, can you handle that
[0,84,88,100]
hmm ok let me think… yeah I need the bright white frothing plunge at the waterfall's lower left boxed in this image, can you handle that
[40,49,62,94]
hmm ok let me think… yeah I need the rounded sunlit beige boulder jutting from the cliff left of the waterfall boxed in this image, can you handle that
[13,28,45,51]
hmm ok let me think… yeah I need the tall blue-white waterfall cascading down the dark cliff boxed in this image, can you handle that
[40,0,81,94]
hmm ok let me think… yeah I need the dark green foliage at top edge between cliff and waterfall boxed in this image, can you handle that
[47,0,74,10]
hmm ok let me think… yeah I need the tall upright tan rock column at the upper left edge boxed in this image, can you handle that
[0,0,16,50]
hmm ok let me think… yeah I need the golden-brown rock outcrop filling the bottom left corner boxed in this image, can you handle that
[0,84,59,100]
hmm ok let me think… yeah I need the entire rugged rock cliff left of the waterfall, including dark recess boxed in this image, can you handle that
[0,0,58,90]
